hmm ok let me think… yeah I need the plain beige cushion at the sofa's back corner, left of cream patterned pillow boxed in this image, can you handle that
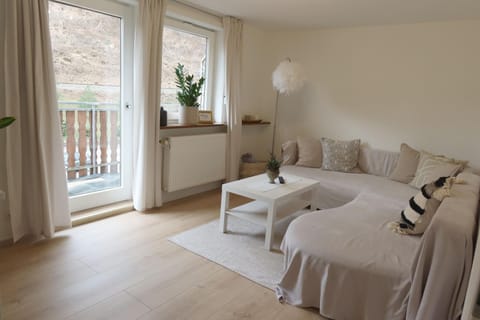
[358,146,400,177]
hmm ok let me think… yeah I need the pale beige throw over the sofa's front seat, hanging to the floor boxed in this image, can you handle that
[276,193,420,320]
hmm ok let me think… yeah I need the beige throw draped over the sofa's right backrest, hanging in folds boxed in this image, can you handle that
[407,173,480,320]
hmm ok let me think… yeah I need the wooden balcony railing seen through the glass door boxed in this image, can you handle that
[58,101,121,182]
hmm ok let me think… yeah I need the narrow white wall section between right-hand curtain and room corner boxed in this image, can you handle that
[241,24,276,160]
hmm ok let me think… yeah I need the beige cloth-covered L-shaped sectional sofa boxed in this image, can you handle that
[276,140,480,320]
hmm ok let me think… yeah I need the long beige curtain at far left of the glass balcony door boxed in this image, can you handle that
[0,0,71,241]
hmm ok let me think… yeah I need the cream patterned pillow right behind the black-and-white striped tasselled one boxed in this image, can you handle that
[410,151,466,189]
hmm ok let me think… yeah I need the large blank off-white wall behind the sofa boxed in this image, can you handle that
[262,20,480,168]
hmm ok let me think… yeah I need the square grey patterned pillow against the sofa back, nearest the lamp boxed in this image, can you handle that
[321,138,360,172]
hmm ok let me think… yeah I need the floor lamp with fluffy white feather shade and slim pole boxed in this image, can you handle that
[270,58,306,155]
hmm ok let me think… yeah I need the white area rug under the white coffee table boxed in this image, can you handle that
[169,212,301,290]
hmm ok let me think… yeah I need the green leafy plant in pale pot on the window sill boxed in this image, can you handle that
[175,63,205,124]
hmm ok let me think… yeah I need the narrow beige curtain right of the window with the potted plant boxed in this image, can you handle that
[223,17,243,181]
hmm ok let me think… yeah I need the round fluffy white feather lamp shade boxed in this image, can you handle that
[272,59,306,95]
